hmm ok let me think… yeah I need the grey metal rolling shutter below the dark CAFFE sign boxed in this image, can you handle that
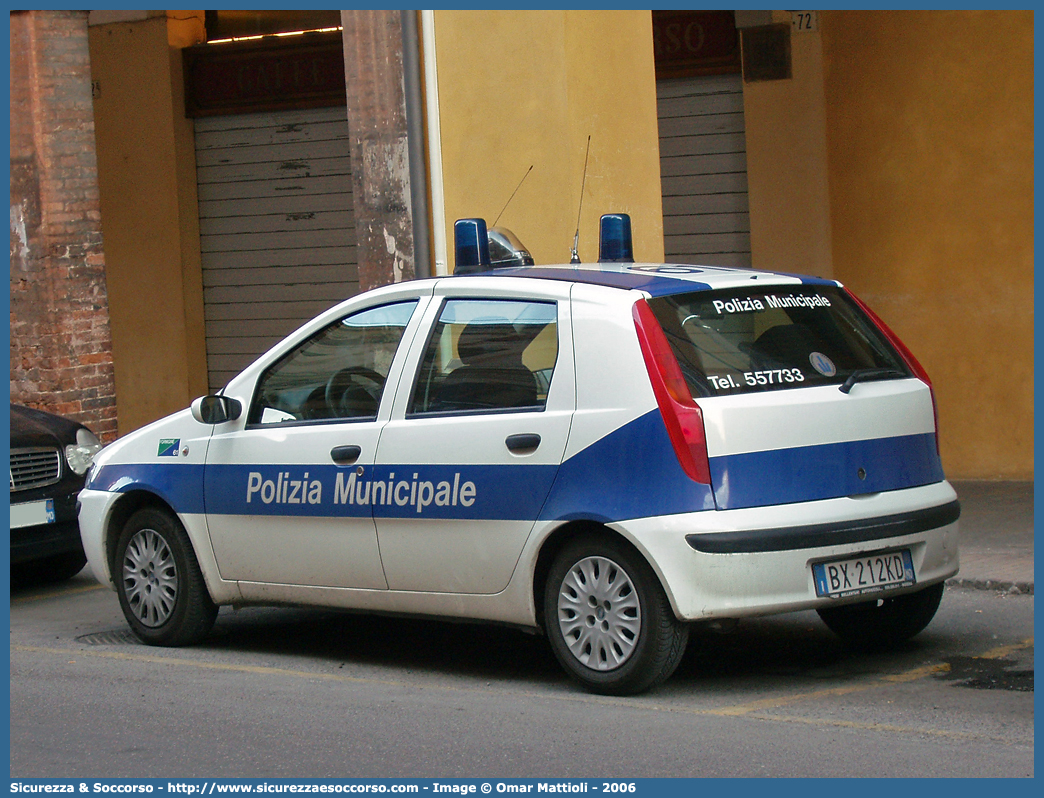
[195,108,358,391]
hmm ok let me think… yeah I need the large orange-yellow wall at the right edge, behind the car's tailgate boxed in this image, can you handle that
[821,11,1034,479]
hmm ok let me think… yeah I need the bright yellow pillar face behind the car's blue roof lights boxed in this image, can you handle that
[434,10,663,269]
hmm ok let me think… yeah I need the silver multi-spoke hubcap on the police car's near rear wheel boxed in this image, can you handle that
[559,557,642,671]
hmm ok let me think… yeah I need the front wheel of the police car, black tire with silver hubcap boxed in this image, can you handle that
[113,508,217,646]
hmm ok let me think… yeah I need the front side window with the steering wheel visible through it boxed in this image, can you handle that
[248,300,418,425]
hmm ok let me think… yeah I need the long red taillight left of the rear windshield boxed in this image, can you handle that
[634,300,711,485]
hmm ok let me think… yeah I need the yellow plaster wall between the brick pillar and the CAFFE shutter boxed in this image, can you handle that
[90,11,207,435]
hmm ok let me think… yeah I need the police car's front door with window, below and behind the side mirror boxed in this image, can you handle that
[205,291,426,589]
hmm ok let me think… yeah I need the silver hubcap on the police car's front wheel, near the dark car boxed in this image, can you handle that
[123,530,177,627]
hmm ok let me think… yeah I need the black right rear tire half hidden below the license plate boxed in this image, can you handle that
[816,582,944,651]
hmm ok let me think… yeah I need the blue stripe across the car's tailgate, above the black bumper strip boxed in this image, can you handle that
[711,432,944,510]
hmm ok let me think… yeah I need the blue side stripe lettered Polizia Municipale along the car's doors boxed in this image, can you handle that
[91,409,714,522]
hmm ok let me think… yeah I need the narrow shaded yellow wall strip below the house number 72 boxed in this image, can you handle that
[743,22,833,277]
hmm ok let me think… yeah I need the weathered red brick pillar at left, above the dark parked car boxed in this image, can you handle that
[10,10,116,442]
